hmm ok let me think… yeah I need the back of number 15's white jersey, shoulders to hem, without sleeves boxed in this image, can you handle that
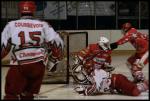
[5,19,49,64]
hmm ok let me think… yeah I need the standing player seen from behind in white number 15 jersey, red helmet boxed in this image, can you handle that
[1,1,63,100]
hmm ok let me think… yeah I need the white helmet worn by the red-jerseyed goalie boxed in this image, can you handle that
[98,37,110,50]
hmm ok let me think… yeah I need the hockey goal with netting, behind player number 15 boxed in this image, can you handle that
[43,32,88,84]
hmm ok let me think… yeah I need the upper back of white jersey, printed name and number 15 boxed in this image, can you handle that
[9,19,44,47]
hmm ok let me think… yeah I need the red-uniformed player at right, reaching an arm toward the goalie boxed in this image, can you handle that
[110,23,149,82]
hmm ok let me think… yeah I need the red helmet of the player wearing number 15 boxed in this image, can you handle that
[19,1,36,14]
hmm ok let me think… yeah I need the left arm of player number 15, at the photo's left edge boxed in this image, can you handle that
[1,24,11,59]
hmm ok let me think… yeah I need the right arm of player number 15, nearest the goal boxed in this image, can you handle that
[44,22,64,71]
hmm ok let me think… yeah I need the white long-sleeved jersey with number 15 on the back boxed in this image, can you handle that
[1,19,63,65]
